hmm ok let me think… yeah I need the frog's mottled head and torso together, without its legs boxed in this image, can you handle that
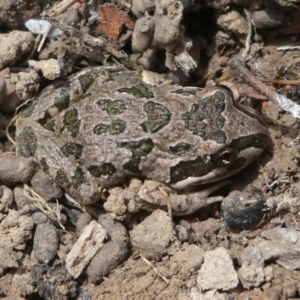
[20,68,268,187]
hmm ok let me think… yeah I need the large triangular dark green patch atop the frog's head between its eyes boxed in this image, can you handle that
[181,91,226,144]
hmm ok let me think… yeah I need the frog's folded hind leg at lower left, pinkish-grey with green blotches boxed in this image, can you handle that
[16,117,100,205]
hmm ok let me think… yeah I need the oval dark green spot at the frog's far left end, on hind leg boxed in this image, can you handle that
[17,126,37,157]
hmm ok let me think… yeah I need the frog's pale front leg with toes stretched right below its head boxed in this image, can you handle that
[136,180,230,216]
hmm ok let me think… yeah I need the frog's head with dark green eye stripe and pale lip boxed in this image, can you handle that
[170,86,269,188]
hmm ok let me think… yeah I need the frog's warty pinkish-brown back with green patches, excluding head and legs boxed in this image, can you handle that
[47,75,206,186]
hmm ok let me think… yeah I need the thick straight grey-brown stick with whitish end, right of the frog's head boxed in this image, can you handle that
[228,58,300,118]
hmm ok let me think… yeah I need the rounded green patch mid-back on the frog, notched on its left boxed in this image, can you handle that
[140,101,171,133]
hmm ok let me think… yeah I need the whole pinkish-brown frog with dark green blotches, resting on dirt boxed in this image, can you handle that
[16,67,269,213]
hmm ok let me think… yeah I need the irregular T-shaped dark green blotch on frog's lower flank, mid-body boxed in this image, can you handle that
[117,138,154,174]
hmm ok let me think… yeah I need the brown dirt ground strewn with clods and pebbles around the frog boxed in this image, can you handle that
[0,0,300,300]
